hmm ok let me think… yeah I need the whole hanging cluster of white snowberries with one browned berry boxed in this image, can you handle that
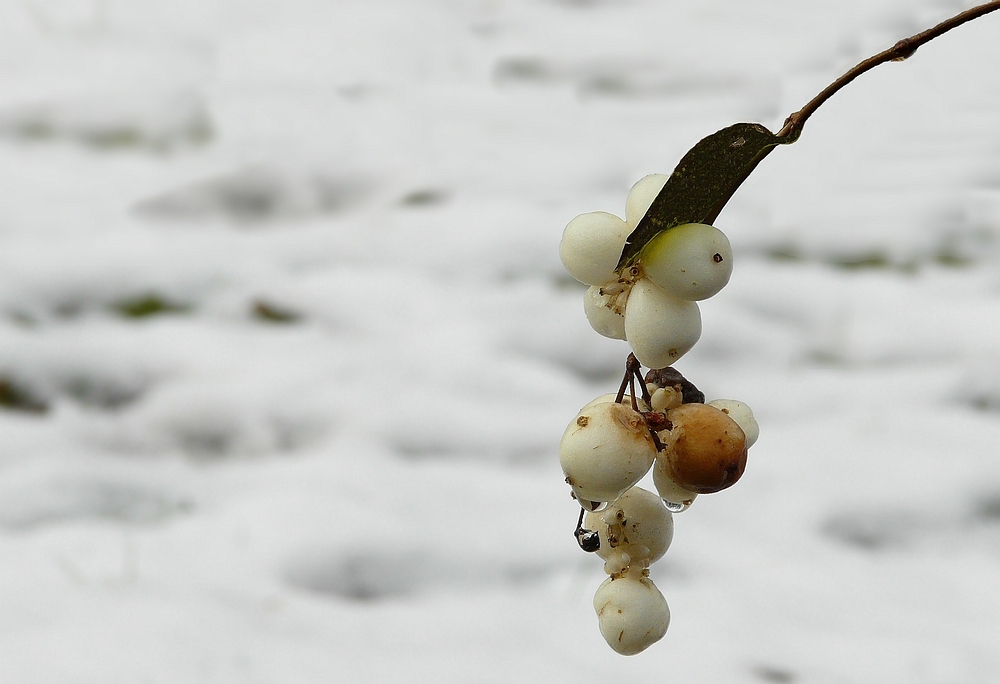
[559,175,758,655]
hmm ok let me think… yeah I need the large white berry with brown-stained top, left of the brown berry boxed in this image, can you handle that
[559,402,656,501]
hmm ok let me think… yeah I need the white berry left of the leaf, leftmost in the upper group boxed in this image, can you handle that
[559,211,630,285]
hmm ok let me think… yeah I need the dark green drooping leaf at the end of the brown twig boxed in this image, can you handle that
[618,123,798,269]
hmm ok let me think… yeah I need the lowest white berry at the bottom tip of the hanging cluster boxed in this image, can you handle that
[594,572,670,655]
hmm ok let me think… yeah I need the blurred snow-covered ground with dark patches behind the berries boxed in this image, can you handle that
[0,0,1000,684]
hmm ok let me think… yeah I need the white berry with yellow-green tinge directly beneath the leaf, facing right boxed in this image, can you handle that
[640,223,733,301]
